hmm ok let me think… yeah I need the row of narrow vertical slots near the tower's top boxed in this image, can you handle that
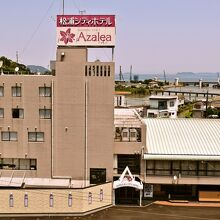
[85,65,111,76]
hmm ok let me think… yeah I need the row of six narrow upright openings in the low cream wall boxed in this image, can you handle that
[9,189,104,207]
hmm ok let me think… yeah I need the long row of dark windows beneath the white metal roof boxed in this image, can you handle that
[146,160,220,176]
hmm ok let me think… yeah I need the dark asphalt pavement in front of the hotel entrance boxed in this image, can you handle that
[84,204,220,220]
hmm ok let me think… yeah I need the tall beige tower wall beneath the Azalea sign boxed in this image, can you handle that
[54,48,114,180]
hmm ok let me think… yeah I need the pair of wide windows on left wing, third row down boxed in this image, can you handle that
[1,131,44,142]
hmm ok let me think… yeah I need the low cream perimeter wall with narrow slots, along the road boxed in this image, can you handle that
[0,183,112,216]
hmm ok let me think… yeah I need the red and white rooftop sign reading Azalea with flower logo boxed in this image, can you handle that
[57,15,115,47]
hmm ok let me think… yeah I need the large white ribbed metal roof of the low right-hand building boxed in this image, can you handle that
[144,118,220,160]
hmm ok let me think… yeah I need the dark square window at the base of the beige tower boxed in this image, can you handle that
[90,168,106,184]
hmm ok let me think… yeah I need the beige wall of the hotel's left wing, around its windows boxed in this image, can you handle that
[0,75,53,177]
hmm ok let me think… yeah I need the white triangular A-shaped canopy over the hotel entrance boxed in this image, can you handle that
[113,166,143,189]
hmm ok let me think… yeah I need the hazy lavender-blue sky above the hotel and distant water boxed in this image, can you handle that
[0,0,220,73]
